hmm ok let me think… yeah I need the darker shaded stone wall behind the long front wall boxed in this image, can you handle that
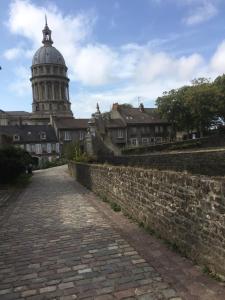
[98,150,225,176]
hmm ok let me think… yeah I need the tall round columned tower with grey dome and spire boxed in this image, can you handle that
[31,19,73,123]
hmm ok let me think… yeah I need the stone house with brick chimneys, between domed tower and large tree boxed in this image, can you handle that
[91,103,175,152]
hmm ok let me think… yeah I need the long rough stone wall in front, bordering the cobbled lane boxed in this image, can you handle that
[69,163,225,276]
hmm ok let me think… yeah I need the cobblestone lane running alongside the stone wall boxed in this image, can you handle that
[0,166,225,300]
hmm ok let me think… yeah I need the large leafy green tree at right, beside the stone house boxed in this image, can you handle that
[156,75,225,137]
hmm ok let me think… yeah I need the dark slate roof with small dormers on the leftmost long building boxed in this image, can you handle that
[0,125,57,143]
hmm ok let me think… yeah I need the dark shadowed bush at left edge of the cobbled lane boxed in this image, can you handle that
[0,146,32,184]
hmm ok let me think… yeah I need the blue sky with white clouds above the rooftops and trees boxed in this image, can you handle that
[0,0,225,118]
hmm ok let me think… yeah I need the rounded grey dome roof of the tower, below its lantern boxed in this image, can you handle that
[32,44,65,66]
